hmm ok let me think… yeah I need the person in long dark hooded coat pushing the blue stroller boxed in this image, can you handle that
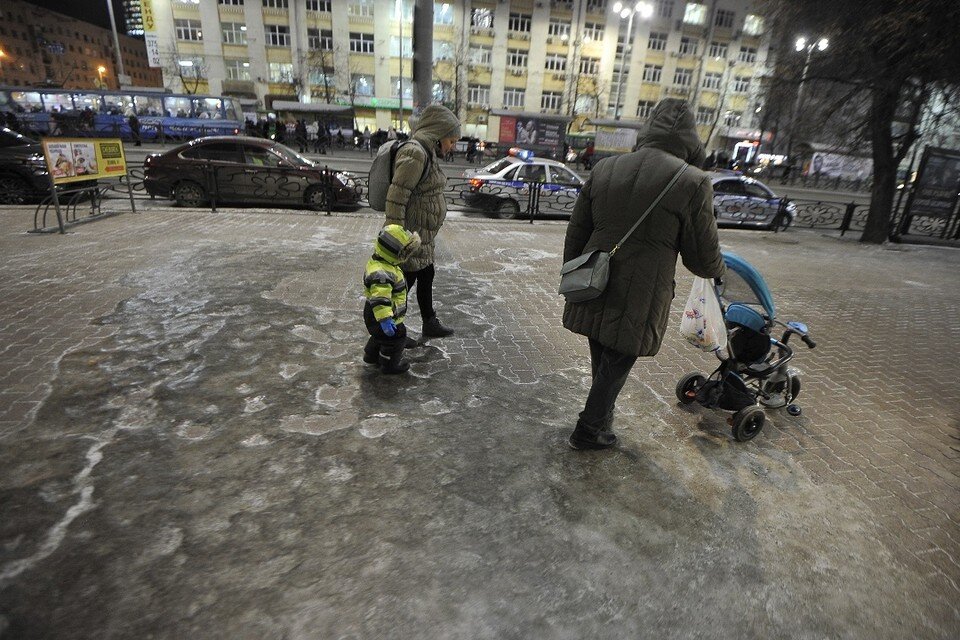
[563,98,724,449]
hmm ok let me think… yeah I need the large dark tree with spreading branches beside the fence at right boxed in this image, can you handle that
[765,0,960,243]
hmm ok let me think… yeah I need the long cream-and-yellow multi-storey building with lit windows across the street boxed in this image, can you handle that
[141,0,769,147]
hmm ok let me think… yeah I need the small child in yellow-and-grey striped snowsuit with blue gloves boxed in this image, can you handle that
[363,224,420,373]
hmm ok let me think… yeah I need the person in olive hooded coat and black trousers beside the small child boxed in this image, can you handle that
[386,104,460,338]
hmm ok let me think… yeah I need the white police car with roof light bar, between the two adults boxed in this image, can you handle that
[462,149,583,219]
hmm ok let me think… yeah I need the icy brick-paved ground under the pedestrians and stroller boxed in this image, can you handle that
[0,209,960,639]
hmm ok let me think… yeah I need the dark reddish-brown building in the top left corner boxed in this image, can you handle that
[0,0,163,89]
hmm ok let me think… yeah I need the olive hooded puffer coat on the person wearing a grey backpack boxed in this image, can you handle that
[386,104,460,271]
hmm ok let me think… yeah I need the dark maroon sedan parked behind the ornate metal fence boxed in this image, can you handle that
[143,136,362,209]
